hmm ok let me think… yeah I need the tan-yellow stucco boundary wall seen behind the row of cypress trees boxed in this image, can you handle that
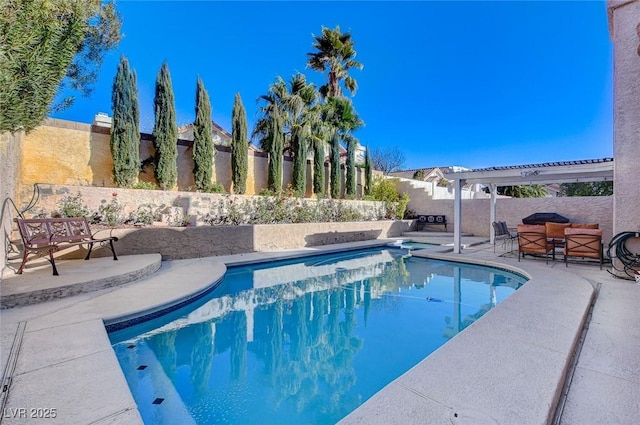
[18,119,350,202]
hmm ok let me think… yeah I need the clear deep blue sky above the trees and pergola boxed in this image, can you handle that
[52,0,613,169]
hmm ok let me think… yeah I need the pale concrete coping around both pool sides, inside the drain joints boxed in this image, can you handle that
[2,240,594,424]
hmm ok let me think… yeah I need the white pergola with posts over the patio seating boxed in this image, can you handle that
[447,158,613,254]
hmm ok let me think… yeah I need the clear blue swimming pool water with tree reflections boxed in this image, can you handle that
[110,248,526,425]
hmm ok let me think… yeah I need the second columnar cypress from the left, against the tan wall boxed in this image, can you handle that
[153,62,178,190]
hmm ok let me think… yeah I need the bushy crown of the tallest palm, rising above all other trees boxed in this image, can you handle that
[307,26,363,98]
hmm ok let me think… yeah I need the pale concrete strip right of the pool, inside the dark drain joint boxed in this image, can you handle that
[339,251,595,425]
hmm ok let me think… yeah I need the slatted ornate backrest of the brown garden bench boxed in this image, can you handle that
[16,217,91,245]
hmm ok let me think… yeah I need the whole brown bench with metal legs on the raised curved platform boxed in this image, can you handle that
[15,217,118,276]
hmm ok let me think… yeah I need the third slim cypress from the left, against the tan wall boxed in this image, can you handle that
[193,77,215,190]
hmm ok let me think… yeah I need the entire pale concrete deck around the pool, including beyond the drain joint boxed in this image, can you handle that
[0,240,640,425]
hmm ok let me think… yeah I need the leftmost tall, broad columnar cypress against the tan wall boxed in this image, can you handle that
[110,55,140,187]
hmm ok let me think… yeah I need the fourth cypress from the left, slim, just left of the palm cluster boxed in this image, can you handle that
[231,93,249,195]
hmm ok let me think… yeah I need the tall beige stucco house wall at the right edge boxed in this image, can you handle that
[608,1,640,233]
